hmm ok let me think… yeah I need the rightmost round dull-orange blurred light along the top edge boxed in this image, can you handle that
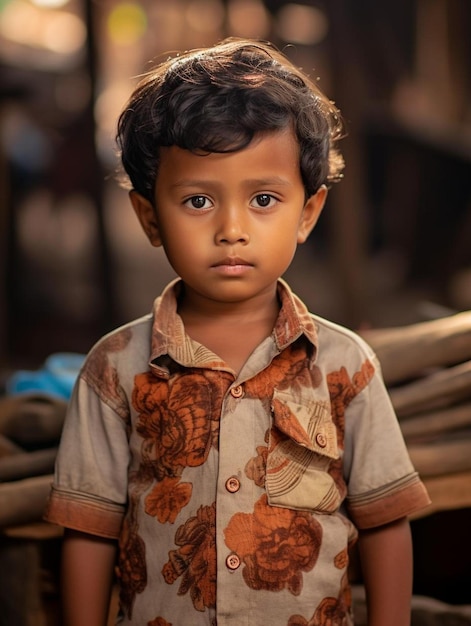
[277,4,329,45]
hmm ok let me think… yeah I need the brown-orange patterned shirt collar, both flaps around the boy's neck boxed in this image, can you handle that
[150,278,317,376]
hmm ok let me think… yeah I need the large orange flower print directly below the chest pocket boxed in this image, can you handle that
[224,495,322,595]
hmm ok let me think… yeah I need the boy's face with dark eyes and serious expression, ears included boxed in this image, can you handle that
[131,131,326,310]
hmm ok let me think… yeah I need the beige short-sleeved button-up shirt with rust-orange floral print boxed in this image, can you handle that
[46,281,429,626]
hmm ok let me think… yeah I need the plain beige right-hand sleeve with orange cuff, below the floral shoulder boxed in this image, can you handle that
[344,355,430,529]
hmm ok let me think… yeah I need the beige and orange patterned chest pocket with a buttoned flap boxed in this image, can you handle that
[265,390,342,513]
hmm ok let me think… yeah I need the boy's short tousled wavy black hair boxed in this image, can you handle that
[117,38,343,203]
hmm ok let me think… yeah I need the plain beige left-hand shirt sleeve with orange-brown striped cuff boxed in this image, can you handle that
[44,376,129,538]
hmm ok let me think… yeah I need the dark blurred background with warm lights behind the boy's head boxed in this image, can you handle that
[0,0,471,369]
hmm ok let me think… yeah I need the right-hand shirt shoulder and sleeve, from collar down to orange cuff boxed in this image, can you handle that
[317,318,430,528]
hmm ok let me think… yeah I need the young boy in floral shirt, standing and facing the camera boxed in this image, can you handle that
[47,39,429,626]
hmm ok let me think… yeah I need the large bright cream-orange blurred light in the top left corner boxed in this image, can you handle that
[0,0,86,54]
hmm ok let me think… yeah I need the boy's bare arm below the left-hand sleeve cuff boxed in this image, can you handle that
[62,529,116,626]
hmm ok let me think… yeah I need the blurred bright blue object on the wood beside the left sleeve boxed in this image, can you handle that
[6,352,85,400]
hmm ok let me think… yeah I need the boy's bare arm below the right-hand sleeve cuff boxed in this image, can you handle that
[359,517,412,626]
